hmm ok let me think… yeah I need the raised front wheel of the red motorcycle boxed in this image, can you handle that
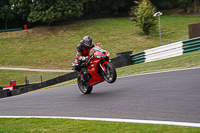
[103,62,117,83]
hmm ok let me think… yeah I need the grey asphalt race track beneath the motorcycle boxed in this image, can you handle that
[0,68,200,123]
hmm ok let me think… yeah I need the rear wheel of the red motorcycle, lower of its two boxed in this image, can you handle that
[77,75,93,94]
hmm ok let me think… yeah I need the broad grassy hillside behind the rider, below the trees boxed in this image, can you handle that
[0,16,200,69]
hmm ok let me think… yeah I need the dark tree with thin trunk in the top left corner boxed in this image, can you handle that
[0,0,15,29]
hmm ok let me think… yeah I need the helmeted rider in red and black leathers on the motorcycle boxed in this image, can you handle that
[75,36,94,78]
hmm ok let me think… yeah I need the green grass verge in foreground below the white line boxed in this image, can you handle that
[0,118,200,133]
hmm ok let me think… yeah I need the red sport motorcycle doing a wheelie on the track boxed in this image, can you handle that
[72,45,117,94]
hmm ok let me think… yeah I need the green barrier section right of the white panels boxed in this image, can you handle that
[183,37,200,54]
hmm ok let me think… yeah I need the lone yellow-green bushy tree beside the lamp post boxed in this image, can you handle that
[130,0,158,35]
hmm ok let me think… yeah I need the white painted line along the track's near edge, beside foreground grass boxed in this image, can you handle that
[0,116,200,127]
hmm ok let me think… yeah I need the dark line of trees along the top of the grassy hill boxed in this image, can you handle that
[0,0,200,29]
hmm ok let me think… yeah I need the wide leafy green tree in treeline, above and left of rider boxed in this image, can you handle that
[28,0,87,26]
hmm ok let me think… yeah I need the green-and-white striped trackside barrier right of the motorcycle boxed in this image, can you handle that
[131,37,200,64]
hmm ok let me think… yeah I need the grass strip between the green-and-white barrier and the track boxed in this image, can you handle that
[117,51,200,76]
